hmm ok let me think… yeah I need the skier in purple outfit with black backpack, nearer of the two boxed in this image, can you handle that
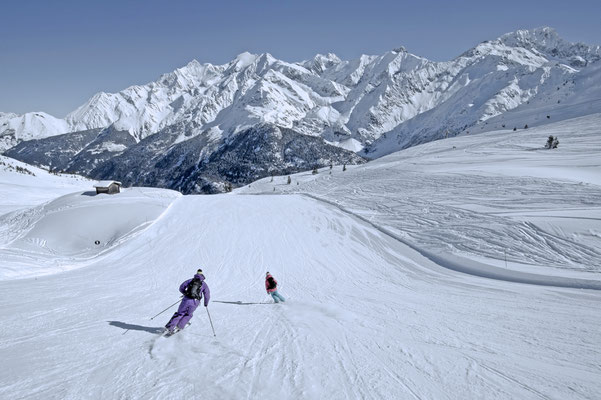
[165,269,211,334]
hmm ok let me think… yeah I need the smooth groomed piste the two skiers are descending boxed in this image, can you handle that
[0,196,601,399]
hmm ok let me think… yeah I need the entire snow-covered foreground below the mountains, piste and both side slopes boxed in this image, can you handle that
[0,114,601,399]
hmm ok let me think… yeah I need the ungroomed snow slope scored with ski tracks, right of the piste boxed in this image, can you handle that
[239,114,601,280]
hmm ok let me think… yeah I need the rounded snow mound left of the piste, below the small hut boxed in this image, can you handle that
[0,188,181,278]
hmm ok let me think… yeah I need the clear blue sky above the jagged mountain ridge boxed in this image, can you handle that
[0,0,601,117]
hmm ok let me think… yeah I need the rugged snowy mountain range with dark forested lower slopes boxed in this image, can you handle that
[0,28,601,193]
